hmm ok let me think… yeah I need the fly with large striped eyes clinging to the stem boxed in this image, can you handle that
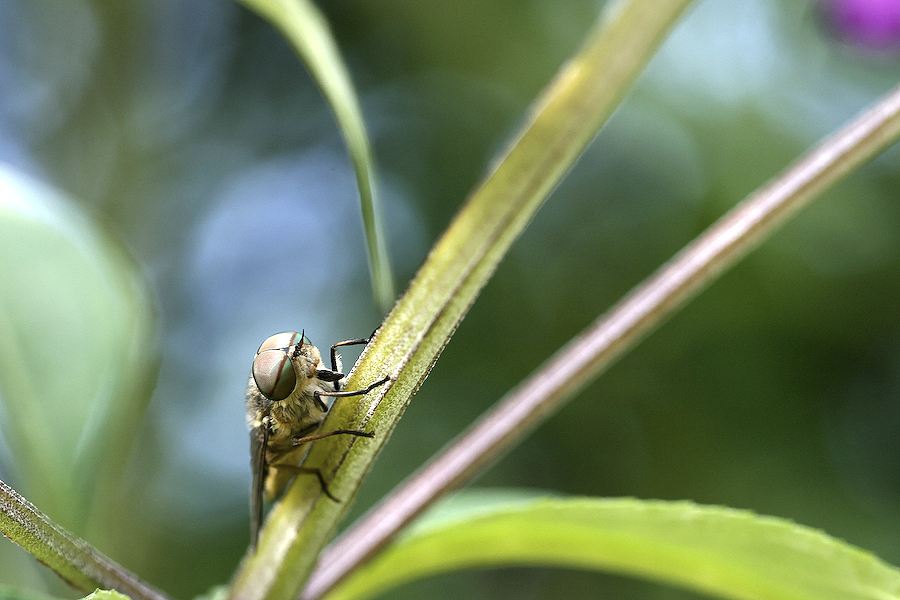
[247,331,389,548]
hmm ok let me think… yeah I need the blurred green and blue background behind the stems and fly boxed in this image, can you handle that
[0,0,900,599]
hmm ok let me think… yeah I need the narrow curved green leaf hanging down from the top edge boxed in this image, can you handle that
[240,0,394,310]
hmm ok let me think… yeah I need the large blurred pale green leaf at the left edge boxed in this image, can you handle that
[0,165,156,527]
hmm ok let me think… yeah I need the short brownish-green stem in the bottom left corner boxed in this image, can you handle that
[0,481,169,600]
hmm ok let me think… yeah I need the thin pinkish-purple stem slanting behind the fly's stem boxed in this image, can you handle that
[303,81,900,600]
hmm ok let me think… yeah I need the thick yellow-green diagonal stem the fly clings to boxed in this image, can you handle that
[230,0,690,600]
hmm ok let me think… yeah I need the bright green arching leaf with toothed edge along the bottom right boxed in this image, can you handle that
[327,493,900,600]
